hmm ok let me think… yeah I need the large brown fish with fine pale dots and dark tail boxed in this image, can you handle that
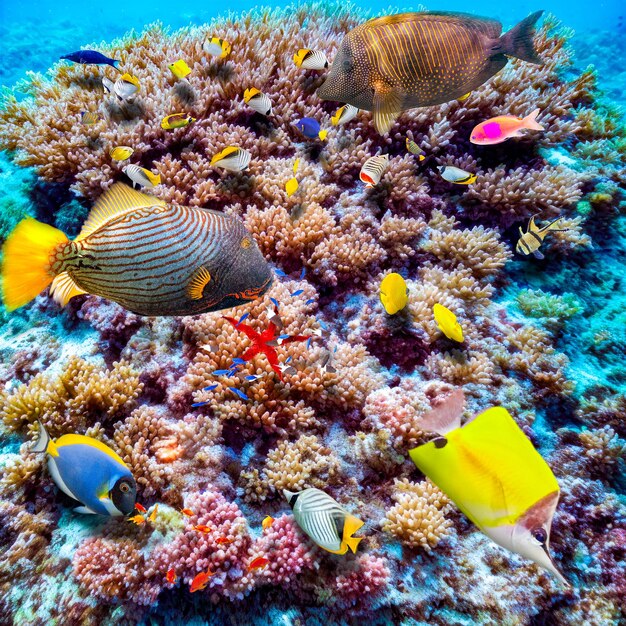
[317,11,543,134]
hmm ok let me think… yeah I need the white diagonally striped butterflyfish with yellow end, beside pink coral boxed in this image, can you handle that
[283,487,364,554]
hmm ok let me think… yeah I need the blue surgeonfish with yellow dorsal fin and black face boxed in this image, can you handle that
[31,422,137,516]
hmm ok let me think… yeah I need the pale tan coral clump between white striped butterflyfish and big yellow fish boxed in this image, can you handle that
[382,479,452,552]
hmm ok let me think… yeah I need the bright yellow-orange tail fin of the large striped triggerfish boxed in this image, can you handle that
[2,217,69,311]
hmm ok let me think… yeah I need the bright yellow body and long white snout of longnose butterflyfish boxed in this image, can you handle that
[409,407,567,584]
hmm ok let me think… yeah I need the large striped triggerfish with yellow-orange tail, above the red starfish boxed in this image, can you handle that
[2,183,272,315]
